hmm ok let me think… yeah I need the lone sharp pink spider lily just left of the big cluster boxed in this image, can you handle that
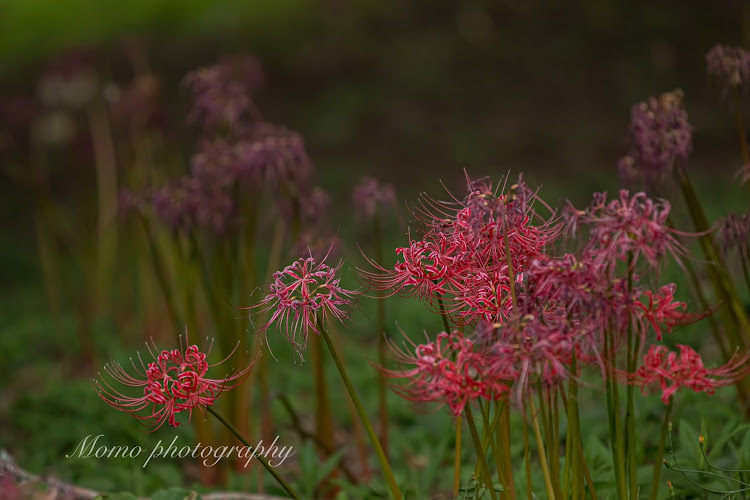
[241,255,359,359]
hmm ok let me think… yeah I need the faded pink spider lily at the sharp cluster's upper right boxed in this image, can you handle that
[566,189,687,272]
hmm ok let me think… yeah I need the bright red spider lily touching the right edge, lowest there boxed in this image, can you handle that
[620,345,750,404]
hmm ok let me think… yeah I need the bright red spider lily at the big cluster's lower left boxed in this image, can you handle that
[380,331,513,416]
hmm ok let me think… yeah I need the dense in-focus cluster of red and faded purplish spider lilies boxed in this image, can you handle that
[362,174,750,415]
